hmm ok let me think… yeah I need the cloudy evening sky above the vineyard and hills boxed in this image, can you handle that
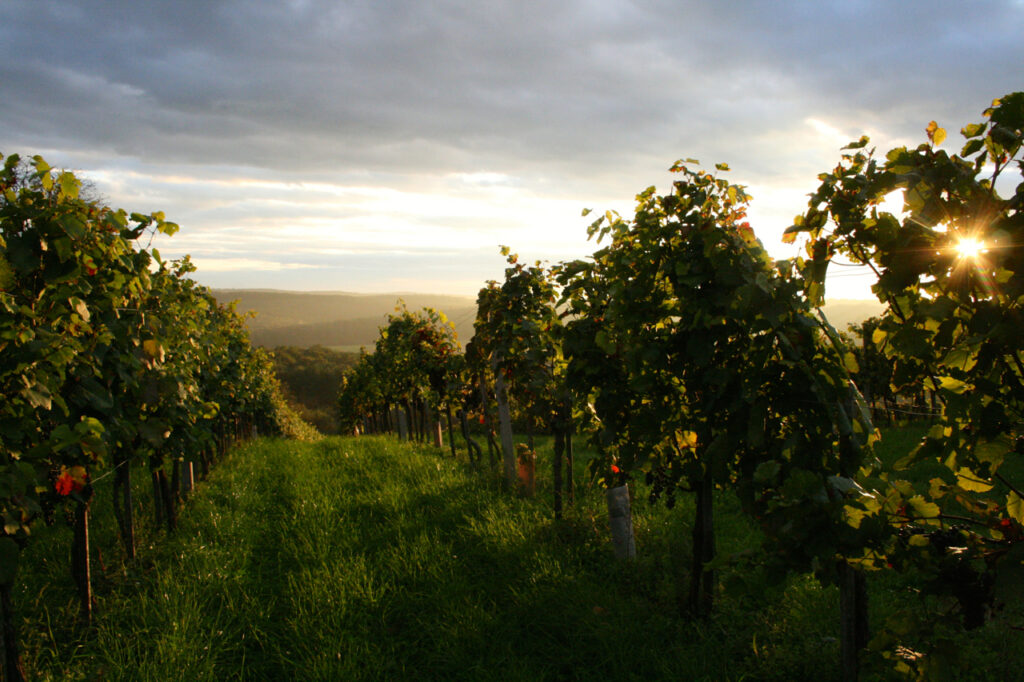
[0,0,1024,299]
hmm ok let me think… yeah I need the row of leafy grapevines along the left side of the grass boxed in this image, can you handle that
[0,156,313,680]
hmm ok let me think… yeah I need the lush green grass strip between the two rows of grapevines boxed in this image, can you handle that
[16,428,1019,680]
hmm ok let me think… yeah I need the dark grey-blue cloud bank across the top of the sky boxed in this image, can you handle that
[0,0,1024,186]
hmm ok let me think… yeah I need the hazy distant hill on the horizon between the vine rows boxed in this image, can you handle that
[213,289,476,348]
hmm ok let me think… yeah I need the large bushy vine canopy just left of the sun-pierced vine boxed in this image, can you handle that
[561,162,877,574]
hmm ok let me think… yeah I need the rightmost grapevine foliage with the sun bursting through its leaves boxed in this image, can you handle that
[787,92,1024,671]
